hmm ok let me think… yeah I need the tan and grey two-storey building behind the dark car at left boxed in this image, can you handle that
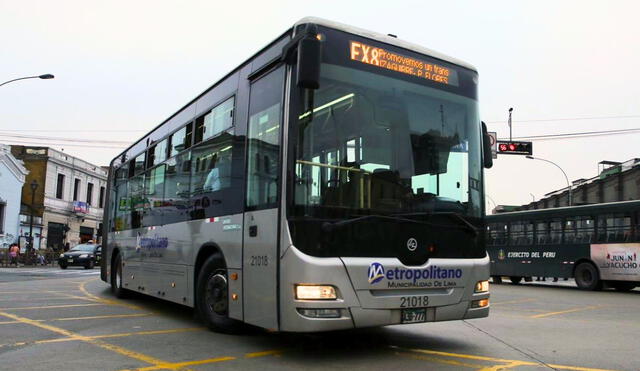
[11,146,107,251]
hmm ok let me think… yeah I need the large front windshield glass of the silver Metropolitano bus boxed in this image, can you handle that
[290,63,481,219]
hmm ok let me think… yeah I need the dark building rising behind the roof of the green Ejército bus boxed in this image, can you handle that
[493,158,640,213]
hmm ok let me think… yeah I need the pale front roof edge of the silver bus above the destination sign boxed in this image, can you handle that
[294,17,478,72]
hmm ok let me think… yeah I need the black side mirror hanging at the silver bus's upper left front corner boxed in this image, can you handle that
[296,24,322,89]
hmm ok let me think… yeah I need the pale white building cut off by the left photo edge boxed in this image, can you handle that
[0,144,28,249]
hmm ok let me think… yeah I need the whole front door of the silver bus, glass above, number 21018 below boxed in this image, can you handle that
[242,66,284,329]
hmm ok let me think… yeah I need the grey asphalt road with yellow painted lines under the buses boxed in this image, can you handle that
[0,269,640,371]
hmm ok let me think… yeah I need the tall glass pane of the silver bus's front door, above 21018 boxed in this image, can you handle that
[246,67,284,210]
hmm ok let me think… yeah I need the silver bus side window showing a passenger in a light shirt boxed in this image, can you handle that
[190,133,233,219]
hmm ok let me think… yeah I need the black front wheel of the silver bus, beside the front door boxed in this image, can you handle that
[196,254,242,333]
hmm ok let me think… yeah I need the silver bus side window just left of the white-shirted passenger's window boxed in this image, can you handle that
[162,151,191,224]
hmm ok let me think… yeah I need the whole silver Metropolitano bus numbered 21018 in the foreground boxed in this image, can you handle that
[101,18,491,332]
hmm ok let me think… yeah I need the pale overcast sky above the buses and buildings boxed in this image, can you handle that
[0,0,640,207]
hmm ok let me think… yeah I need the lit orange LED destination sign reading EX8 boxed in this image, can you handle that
[349,41,457,85]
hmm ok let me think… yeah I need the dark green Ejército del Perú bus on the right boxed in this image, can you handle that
[487,201,640,291]
